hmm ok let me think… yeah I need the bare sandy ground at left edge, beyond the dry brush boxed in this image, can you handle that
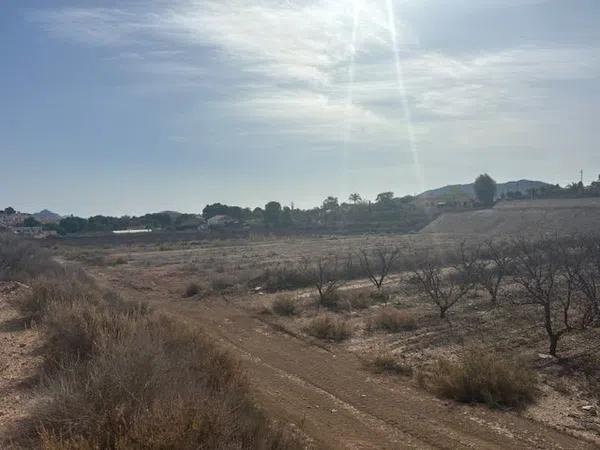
[0,282,42,445]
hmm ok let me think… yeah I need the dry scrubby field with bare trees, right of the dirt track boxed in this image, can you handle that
[52,232,600,442]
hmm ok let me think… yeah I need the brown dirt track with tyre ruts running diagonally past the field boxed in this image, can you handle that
[98,272,596,449]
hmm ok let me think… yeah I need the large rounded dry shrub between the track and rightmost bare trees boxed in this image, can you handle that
[425,350,536,407]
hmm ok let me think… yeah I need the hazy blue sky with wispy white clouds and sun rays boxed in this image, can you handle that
[0,0,600,216]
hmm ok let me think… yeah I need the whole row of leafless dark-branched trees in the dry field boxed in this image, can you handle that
[305,236,600,355]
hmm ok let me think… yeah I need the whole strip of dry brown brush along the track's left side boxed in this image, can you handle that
[0,238,302,449]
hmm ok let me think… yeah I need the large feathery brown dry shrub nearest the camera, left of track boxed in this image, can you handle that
[33,316,297,449]
